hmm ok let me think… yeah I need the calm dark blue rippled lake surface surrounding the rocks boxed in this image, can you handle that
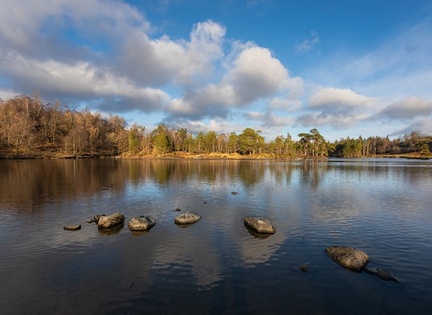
[0,159,432,314]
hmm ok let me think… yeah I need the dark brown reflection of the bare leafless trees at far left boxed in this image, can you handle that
[0,160,127,209]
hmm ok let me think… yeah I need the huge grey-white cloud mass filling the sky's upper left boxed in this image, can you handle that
[0,0,230,113]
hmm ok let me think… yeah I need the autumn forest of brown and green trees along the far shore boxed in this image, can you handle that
[0,96,432,158]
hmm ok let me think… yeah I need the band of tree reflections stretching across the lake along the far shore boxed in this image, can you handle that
[0,159,430,214]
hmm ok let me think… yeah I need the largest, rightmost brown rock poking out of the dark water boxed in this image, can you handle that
[325,246,369,271]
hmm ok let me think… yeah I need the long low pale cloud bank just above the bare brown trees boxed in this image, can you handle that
[0,54,169,111]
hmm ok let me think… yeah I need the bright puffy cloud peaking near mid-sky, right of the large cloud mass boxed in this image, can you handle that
[170,45,302,119]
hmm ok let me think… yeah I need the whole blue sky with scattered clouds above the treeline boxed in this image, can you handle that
[0,0,432,142]
